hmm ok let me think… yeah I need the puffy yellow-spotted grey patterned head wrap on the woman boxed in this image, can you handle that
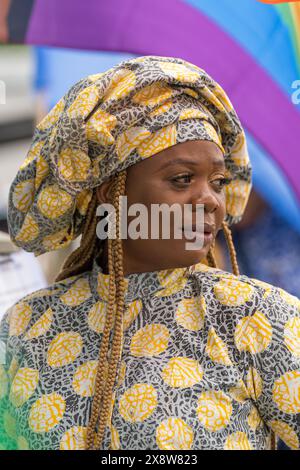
[8,56,251,256]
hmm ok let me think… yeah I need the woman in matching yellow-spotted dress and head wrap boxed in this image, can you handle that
[1,56,299,450]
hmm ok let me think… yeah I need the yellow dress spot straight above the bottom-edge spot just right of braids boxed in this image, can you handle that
[162,357,203,388]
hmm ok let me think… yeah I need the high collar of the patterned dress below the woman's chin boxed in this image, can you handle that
[90,259,211,302]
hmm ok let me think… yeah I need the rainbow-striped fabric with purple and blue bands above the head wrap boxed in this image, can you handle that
[2,0,300,231]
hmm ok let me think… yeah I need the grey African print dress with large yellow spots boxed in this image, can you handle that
[0,262,300,450]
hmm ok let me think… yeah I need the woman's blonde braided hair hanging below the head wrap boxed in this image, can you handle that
[56,170,248,450]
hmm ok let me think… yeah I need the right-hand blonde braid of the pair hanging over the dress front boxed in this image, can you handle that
[95,172,126,449]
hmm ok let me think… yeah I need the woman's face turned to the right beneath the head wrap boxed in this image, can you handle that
[98,140,225,275]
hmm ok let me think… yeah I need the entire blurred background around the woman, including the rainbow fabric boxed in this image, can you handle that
[0,0,300,317]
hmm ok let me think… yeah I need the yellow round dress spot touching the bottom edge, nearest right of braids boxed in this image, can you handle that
[156,417,194,450]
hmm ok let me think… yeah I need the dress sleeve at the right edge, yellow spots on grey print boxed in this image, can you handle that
[235,287,300,449]
